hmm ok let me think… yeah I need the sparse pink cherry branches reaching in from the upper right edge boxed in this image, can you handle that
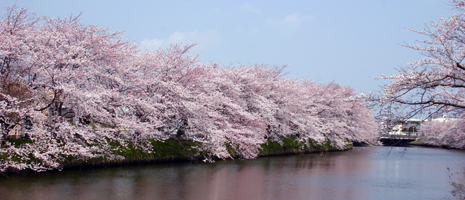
[380,0,465,122]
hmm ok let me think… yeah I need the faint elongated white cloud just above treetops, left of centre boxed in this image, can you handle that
[139,30,222,50]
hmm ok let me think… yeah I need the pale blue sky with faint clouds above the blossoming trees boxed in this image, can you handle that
[0,0,456,93]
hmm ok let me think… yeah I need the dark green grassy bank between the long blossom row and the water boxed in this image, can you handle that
[0,136,353,177]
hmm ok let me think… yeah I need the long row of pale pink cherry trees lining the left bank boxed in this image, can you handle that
[0,6,377,172]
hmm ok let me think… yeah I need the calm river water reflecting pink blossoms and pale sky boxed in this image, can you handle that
[0,147,465,200]
